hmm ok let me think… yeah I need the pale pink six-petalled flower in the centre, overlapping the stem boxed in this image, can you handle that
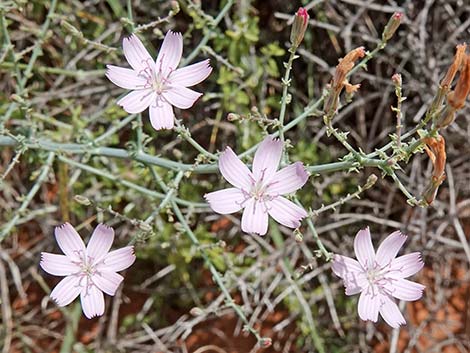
[204,136,308,235]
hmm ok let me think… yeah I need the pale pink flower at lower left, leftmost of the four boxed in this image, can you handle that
[40,223,135,319]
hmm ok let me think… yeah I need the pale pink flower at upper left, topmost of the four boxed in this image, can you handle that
[106,31,212,130]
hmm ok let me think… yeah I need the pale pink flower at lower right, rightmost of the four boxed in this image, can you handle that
[332,228,425,328]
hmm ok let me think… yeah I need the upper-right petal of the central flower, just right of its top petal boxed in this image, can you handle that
[266,162,308,195]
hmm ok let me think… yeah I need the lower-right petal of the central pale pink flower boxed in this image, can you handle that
[266,196,307,228]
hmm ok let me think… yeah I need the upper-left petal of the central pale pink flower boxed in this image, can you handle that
[219,147,253,191]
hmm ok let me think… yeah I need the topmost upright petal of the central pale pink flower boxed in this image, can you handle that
[253,136,283,182]
